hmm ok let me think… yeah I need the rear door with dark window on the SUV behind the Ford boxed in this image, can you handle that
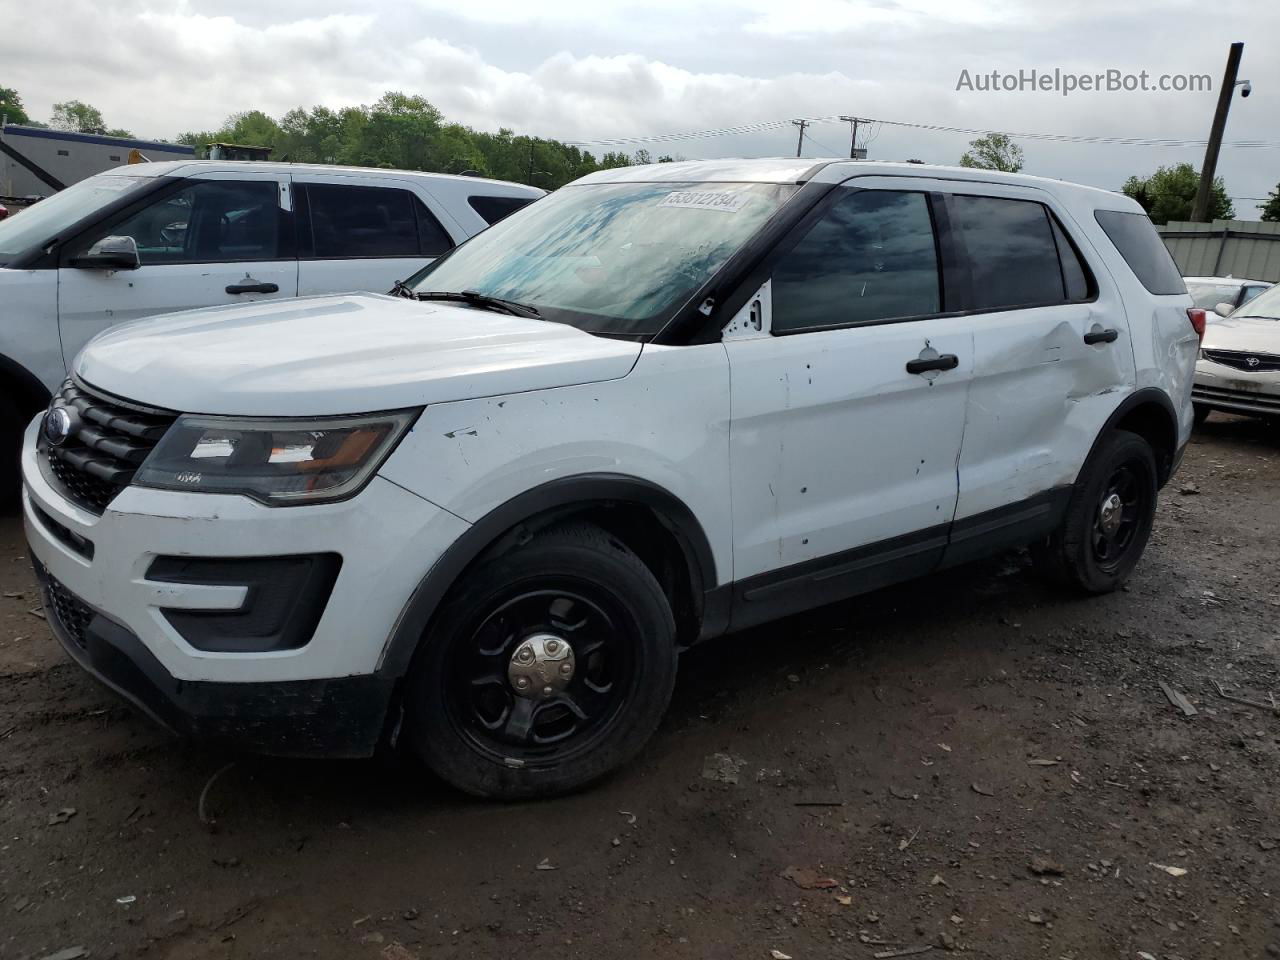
[293,173,465,296]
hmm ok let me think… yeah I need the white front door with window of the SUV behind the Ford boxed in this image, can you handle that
[58,172,298,366]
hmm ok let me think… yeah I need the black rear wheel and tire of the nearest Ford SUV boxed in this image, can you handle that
[1033,430,1157,594]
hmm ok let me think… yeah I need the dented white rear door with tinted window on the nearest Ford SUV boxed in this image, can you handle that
[945,184,1134,561]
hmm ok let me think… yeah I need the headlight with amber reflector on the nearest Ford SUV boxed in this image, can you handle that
[133,410,419,507]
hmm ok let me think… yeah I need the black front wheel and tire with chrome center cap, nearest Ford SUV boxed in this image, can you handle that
[404,524,677,800]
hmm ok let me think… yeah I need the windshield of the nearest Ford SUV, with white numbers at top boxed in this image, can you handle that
[408,183,796,337]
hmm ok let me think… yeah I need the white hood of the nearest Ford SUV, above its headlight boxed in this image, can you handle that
[74,293,641,416]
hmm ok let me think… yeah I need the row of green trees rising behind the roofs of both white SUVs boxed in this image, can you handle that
[178,91,632,189]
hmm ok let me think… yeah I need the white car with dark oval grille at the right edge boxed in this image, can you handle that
[1192,284,1280,424]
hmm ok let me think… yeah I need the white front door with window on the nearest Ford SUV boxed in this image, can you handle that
[724,187,973,626]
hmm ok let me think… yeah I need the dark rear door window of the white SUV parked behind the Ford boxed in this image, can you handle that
[306,183,419,260]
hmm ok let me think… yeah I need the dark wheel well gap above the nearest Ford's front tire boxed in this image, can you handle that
[478,500,703,645]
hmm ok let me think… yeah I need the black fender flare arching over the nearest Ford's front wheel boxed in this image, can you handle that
[378,474,718,677]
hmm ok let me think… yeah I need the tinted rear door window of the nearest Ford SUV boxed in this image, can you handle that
[950,196,1079,310]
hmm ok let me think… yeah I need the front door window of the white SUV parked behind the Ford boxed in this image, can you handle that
[100,180,282,265]
